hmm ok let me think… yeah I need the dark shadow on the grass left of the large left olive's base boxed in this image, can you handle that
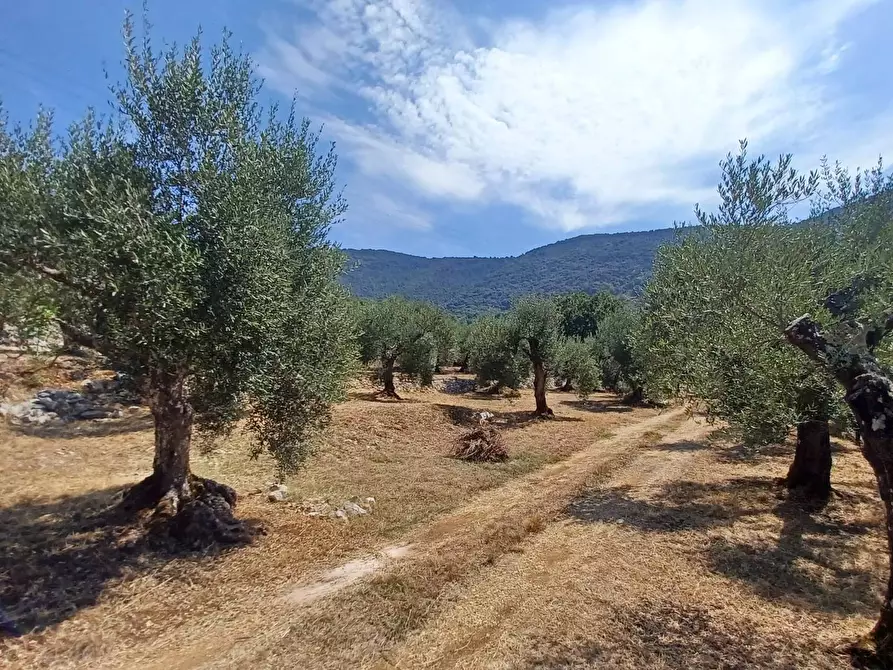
[0,488,237,636]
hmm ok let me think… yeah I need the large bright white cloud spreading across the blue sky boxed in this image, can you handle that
[262,0,870,231]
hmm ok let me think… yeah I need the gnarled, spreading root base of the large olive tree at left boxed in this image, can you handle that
[121,475,263,549]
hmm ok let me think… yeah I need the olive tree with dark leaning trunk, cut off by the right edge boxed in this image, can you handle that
[785,162,893,667]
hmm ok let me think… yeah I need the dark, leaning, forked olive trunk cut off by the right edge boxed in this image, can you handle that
[785,315,893,667]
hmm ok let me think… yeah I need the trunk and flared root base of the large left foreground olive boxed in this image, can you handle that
[123,370,253,547]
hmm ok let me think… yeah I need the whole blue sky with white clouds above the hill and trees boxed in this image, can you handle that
[0,0,893,256]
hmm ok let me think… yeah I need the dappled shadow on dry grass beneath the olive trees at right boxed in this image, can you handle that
[567,477,880,616]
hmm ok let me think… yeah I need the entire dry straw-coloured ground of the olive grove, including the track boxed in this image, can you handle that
[0,360,886,670]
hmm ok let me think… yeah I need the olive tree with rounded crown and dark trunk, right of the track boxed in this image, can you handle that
[644,142,846,498]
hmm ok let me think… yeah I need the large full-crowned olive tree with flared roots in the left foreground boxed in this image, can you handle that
[0,16,354,543]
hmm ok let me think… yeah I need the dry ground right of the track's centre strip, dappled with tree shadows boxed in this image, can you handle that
[372,423,880,670]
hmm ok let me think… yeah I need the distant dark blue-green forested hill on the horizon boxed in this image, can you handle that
[344,228,674,314]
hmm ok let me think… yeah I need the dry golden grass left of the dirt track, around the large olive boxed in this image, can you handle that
[0,360,653,668]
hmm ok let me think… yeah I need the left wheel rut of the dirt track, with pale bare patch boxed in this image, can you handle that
[120,410,686,670]
